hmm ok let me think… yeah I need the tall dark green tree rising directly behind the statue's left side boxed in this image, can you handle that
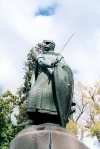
[16,49,36,124]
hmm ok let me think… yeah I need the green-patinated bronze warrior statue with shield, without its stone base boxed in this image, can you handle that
[22,40,75,127]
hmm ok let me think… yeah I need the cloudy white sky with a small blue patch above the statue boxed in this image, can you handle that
[0,0,100,93]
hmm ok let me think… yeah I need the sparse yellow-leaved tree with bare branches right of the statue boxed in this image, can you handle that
[74,79,100,136]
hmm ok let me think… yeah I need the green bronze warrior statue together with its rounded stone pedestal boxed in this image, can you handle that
[10,40,89,149]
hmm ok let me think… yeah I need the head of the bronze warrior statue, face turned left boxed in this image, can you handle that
[42,40,55,51]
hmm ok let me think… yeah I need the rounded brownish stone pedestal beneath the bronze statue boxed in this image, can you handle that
[10,125,89,149]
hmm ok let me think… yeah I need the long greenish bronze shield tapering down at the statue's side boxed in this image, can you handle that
[54,63,74,127]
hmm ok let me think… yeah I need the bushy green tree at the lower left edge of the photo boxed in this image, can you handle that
[0,90,18,149]
